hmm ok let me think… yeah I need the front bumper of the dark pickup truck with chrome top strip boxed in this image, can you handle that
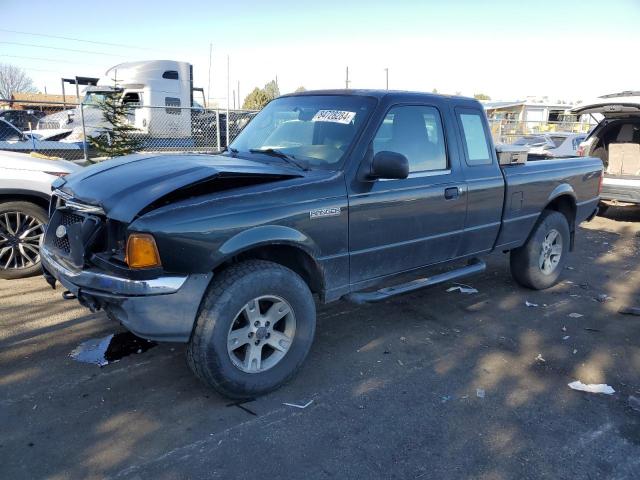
[40,245,213,342]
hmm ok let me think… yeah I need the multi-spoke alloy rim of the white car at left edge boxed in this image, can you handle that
[0,211,44,270]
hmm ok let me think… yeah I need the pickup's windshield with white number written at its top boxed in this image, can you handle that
[230,95,375,169]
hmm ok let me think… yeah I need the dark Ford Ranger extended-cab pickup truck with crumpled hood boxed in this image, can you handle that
[41,90,603,398]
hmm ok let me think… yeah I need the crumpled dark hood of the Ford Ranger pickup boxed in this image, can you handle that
[58,154,301,223]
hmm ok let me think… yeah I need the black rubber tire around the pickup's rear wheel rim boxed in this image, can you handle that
[510,210,571,290]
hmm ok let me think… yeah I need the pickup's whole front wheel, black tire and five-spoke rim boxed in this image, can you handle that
[187,260,316,398]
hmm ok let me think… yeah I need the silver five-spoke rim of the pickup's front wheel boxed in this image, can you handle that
[227,295,296,373]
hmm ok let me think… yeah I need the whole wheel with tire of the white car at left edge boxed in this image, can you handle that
[0,202,48,279]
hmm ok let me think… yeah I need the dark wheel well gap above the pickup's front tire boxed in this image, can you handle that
[214,244,324,294]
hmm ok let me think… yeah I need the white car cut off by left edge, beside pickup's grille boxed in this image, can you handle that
[0,151,82,279]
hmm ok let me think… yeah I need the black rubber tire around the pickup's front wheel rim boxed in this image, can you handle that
[187,260,316,399]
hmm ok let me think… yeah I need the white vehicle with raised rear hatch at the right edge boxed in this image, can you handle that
[572,92,640,211]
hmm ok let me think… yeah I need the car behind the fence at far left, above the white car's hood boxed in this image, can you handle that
[0,119,83,160]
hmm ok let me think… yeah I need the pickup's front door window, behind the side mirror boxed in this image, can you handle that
[373,105,447,172]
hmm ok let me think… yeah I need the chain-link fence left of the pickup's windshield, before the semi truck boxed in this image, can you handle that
[0,100,256,161]
